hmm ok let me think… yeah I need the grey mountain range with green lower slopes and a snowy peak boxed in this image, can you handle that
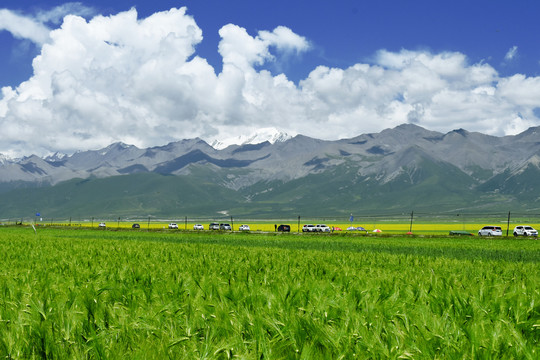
[0,124,540,219]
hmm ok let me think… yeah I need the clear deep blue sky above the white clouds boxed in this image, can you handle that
[0,0,540,86]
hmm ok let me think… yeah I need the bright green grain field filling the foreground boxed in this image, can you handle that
[0,226,540,359]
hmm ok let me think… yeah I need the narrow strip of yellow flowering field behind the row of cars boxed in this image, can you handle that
[0,211,540,236]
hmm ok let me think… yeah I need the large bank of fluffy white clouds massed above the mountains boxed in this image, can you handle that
[0,8,540,156]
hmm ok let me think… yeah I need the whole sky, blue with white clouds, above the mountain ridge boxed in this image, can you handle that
[0,0,540,156]
